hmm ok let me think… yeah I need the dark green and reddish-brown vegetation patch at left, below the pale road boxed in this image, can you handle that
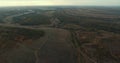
[0,27,45,53]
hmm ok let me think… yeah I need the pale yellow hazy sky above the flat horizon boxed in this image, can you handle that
[0,0,120,6]
